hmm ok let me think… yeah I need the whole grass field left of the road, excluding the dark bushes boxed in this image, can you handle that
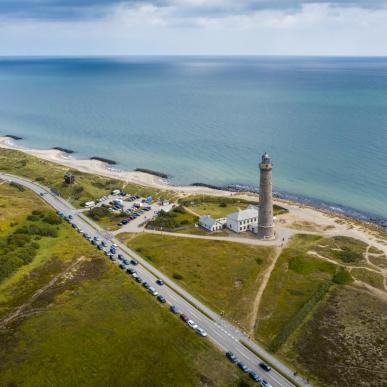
[0,184,252,386]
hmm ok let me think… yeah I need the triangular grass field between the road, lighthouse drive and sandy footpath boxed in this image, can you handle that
[120,234,274,327]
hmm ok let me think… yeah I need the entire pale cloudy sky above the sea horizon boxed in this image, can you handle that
[0,0,387,56]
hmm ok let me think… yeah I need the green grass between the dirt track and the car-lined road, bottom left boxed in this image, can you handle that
[0,257,249,386]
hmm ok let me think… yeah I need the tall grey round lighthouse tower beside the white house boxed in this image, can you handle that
[258,152,274,239]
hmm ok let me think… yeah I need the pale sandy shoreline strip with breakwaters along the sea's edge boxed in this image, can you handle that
[0,135,387,229]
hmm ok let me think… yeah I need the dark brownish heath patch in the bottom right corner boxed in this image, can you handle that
[288,286,387,386]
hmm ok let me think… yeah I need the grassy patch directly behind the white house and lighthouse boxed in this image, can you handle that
[179,195,287,219]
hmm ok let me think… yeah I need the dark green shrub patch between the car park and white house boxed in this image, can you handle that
[147,207,198,232]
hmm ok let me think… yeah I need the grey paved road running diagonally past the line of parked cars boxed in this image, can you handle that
[0,173,306,387]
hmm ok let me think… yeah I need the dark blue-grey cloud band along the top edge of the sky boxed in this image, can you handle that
[0,0,385,21]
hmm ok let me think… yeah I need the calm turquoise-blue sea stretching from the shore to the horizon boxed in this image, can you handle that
[0,57,387,218]
